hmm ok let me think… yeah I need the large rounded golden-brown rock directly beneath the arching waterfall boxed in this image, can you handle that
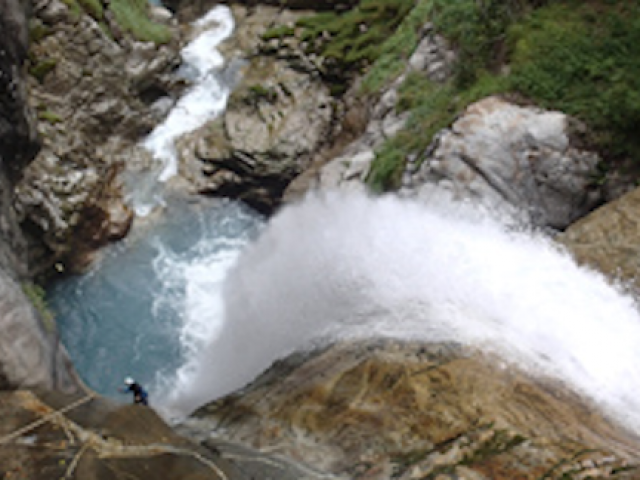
[183,341,640,480]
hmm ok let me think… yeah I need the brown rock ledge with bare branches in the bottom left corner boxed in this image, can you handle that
[0,390,332,480]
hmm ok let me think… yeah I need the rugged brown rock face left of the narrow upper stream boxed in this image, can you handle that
[17,0,179,273]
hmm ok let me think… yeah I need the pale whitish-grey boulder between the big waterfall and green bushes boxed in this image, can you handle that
[403,97,602,230]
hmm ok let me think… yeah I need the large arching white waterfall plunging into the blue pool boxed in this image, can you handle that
[164,194,640,431]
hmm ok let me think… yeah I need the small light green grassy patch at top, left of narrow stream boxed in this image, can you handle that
[109,0,171,43]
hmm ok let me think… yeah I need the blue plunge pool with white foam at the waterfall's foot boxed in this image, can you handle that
[48,198,261,403]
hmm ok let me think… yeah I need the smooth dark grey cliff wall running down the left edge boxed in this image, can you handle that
[0,0,77,390]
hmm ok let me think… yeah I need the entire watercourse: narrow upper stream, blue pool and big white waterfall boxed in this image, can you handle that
[49,3,640,438]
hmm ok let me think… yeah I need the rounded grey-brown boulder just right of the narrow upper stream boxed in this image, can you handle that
[178,7,334,213]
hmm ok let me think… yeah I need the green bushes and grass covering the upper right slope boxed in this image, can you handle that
[364,0,640,191]
